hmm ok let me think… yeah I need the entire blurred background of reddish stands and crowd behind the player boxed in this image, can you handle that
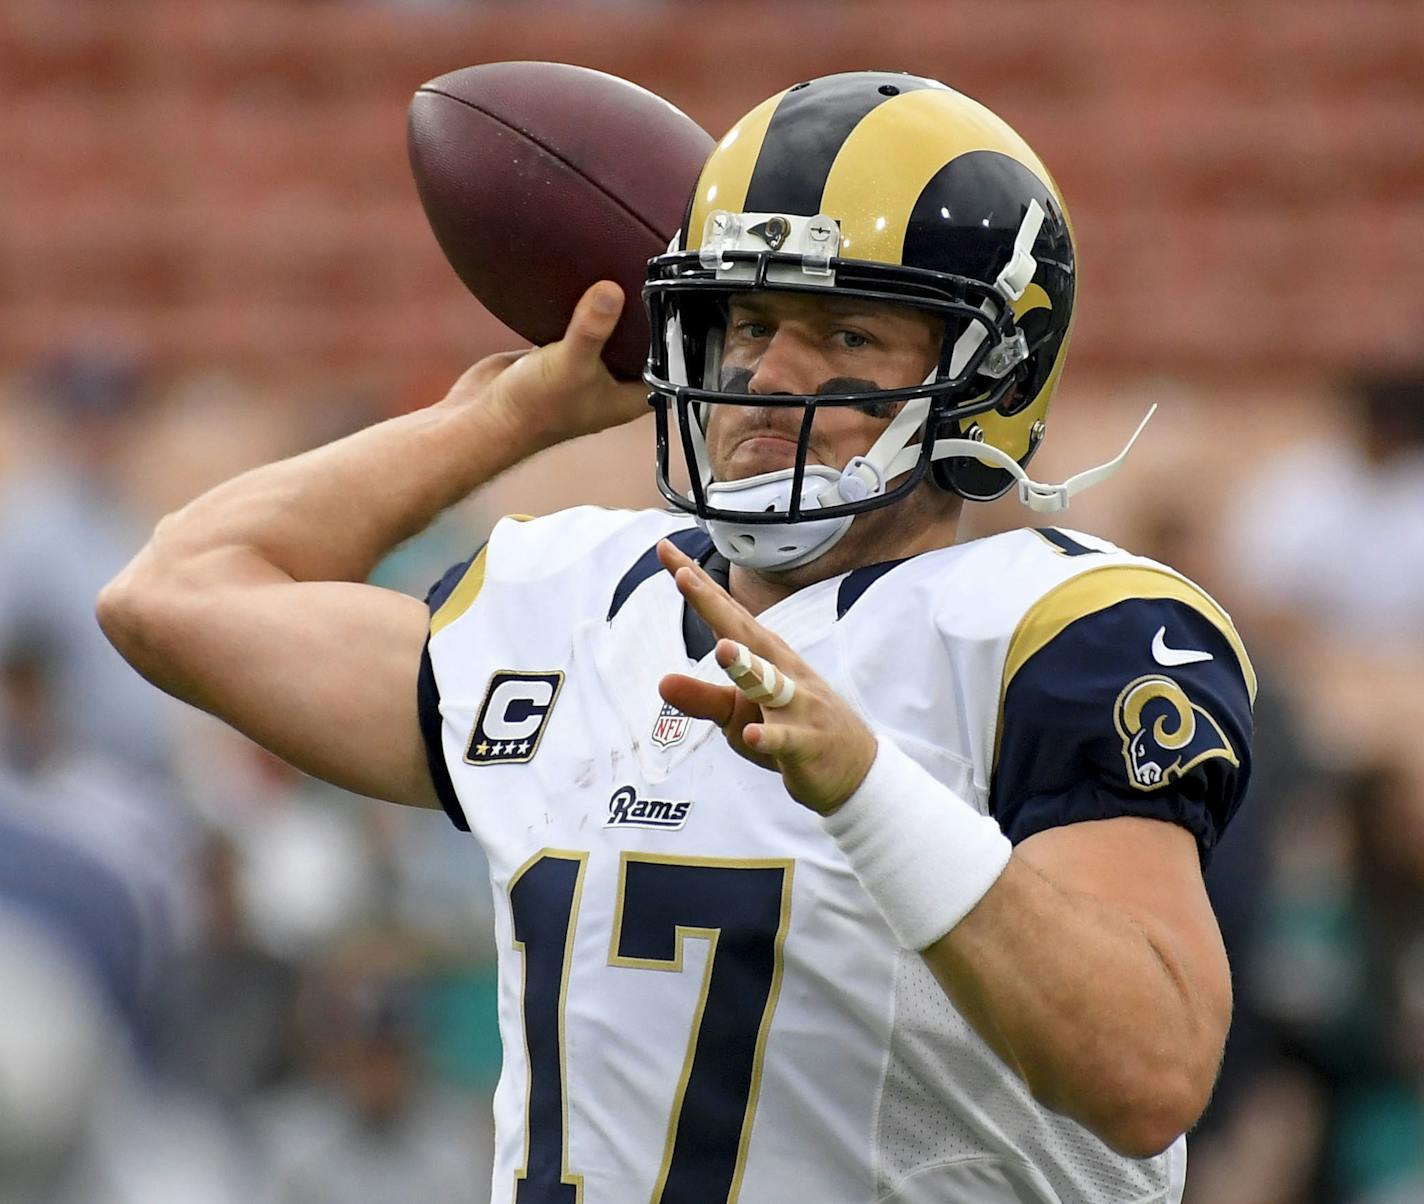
[0,0,1424,1204]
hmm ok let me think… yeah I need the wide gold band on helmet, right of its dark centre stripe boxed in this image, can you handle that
[820,88,1062,263]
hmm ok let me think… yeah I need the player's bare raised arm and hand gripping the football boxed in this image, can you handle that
[98,282,646,807]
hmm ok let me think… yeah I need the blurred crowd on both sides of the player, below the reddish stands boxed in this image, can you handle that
[0,343,1424,1204]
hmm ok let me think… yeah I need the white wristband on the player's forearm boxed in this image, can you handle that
[824,736,1012,949]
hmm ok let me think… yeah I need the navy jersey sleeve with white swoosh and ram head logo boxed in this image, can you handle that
[990,580,1255,865]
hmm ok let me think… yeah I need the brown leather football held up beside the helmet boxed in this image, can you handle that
[407,63,712,380]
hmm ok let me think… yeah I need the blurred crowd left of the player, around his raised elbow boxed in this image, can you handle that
[0,347,498,1204]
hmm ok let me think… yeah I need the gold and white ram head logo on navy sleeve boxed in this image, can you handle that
[1112,673,1239,790]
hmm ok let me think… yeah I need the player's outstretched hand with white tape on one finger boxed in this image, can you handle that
[658,539,876,815]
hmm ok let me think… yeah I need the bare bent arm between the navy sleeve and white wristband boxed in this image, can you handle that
[923,817,1232,1157]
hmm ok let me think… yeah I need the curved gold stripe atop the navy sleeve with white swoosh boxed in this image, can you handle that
[994,565,1256,764]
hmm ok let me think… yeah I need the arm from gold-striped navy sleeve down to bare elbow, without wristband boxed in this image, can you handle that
[926,583,1255,1153]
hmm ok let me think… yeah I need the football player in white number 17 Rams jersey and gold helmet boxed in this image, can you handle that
[100,73,1255,1204]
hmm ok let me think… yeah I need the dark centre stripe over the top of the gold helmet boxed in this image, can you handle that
[743,71,931,216]
